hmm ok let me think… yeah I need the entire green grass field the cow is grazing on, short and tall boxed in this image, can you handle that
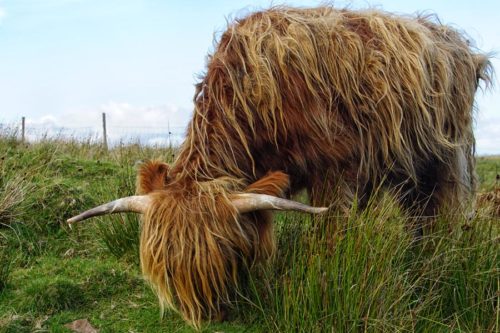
[0,135,500,332]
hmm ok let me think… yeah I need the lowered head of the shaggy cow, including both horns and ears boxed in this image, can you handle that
[68,162,327,326]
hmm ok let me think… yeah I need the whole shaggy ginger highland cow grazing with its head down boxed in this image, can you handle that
[69,6,490,326]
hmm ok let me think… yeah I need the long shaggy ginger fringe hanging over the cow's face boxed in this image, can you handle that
[140,178,259,325]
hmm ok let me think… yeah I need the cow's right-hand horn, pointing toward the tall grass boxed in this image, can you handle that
[231,193,328,214]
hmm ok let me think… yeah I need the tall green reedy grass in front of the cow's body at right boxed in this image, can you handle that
[240,196,500,332]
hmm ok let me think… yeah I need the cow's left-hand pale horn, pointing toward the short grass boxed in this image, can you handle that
[67,195,151,223]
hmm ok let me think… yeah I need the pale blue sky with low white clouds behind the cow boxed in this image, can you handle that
[0,0,500,154]
